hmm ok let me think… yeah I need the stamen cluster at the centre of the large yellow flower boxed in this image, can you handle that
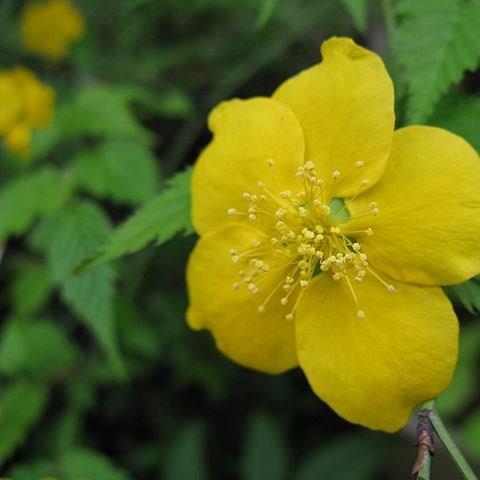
[227,159,395,320]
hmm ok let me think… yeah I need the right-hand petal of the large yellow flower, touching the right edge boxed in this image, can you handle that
[346,126,480,285]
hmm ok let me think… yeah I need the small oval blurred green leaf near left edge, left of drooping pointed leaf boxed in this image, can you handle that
[11,261,53,315]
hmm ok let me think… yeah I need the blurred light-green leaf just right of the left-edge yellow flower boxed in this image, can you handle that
[57,85,151,143]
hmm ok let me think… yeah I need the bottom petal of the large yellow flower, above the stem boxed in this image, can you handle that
[296,275,458,432]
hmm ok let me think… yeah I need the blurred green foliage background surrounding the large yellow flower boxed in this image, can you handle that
[0,0,480,480]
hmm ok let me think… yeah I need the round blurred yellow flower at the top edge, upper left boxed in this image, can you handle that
[21,0,85,61]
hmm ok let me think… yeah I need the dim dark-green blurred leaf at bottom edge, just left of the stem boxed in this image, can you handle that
[294,432,388,480]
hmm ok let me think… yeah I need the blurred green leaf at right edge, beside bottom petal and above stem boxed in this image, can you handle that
[436,324,480,418]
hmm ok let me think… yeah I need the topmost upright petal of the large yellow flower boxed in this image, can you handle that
[273,38,394,197]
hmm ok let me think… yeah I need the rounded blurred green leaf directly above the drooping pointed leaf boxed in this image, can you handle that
[75,140,159,205]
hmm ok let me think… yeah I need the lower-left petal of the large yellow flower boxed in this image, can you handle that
[187,224,297,373]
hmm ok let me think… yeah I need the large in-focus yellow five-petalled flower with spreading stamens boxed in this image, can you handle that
[187,38,480,431]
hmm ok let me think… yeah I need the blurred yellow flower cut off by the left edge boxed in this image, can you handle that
[0,67,55,156]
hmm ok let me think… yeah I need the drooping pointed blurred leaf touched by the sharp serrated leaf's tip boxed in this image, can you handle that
[42,202,123,375]
